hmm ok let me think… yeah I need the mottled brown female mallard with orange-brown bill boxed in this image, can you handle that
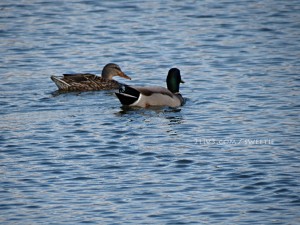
[51,63,131,91]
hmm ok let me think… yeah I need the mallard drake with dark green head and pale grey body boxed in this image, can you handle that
[115,68,185,108]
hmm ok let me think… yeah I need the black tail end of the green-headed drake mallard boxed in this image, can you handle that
[115,85,140,105]
